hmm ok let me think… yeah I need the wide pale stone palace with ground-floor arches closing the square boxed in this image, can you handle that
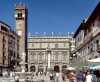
[28,35,75,72]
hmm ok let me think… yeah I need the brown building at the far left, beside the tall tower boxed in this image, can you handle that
[0,21,19,75]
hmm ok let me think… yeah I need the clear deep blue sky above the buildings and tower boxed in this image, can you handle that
[0,0,100,34]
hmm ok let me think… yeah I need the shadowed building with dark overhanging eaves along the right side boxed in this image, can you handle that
[71,3,100,65]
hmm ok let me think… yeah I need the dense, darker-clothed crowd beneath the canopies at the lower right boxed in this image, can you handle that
[62,70,100,82]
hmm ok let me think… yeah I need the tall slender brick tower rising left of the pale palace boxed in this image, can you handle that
[14,5,28,71]
